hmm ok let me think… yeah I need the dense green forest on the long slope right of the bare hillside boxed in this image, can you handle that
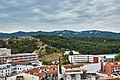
[35,35,120,54]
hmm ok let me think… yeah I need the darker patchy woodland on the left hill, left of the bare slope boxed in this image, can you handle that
[0,38,37,54]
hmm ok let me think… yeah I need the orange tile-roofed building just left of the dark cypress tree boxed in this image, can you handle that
[26,65,58,80]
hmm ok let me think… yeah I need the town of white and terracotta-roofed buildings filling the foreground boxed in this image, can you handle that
[0,48,120,80]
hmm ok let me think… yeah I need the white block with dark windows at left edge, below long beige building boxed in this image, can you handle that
[0,64,11,77]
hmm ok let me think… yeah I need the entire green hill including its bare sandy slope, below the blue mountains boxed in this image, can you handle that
[0,34,120,63]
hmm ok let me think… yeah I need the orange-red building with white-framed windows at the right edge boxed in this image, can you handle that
[101,62,120,76]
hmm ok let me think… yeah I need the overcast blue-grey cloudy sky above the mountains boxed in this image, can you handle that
[0,0,120,33]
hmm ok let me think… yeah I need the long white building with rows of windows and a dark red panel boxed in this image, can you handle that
[69,55,106,63]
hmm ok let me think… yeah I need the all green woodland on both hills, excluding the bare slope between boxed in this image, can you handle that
[0,35,120,54]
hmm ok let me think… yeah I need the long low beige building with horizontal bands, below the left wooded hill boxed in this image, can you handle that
[0,53,37,64]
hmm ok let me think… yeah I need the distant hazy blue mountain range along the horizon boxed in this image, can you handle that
[0,30,120,39]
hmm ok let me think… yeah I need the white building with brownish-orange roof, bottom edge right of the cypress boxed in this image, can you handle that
[62,64,97,80]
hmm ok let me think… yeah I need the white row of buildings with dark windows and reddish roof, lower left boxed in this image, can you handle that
[0,62,34,79]
